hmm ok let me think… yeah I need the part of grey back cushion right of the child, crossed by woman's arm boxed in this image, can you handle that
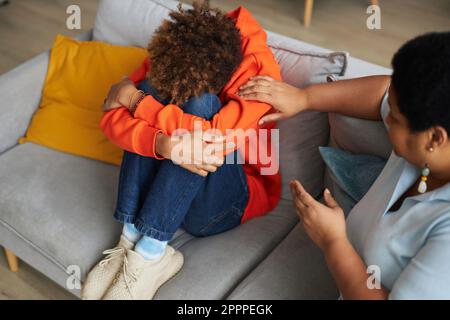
[268,32,348,199]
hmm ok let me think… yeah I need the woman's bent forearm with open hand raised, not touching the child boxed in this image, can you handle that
[291,181,388,300]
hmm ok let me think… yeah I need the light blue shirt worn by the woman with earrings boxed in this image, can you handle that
[347,94,450,299]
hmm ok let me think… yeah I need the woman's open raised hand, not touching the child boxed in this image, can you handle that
[290,181,347,251]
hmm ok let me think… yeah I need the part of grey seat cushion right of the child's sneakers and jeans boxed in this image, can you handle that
[156,200,298,299]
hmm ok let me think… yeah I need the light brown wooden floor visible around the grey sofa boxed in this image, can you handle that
[0,0,450,299]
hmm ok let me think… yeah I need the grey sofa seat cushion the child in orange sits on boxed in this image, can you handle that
[0,143,296,299]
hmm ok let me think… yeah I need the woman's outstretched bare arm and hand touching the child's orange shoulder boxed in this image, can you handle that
[239,76,390,122]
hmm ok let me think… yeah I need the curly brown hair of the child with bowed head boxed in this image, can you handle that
[148,1,242,105]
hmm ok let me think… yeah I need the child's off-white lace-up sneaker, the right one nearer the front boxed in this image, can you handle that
[103,246,184,300]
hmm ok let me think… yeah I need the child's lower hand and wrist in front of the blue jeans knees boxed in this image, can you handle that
[156,131,234,177]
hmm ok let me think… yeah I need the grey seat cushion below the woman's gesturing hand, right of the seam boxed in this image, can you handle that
[227,223,339,300]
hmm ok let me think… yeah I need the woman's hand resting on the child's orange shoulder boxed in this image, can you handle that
[238,76,308,125]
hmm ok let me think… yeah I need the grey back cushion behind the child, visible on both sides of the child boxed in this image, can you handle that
[93,0,348,199]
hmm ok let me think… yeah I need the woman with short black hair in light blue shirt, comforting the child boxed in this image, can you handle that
[239,32,450,299]
